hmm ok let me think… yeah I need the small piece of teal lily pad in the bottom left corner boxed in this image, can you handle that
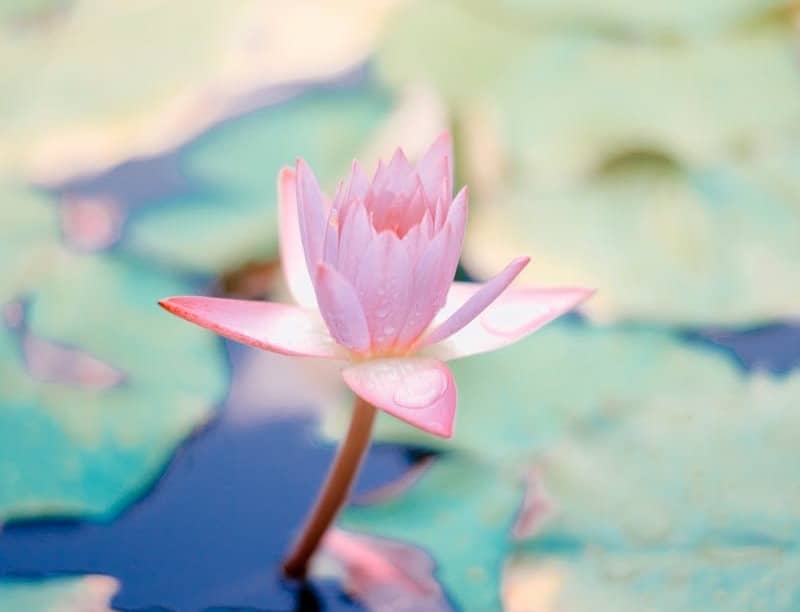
[0,576,119,612]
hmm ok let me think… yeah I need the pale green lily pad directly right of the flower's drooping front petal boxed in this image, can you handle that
[323,323,745,466]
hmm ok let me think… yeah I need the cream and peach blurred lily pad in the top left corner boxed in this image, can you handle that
[0,0,391,184]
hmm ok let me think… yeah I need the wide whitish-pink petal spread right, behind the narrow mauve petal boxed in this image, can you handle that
[424,283,594,360]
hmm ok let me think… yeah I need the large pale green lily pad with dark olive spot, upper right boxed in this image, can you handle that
[378,1,800,324]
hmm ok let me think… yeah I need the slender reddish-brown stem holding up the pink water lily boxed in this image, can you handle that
[283,397,375,580]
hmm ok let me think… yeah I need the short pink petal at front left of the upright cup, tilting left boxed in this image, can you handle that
[314,263,370,353]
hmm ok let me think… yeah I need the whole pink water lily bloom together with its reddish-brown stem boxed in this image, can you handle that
[160,133,592,573]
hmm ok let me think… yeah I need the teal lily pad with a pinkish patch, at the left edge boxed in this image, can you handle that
[0,253,226,519]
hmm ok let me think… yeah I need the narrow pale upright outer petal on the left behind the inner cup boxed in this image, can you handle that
[278,168,317,310]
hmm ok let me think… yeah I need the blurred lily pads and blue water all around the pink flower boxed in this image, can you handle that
[0,0,800,612]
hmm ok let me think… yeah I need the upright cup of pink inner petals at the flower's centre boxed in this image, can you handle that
[297,144,467,356]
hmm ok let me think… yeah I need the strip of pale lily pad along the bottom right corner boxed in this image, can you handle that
[504,546,800,612]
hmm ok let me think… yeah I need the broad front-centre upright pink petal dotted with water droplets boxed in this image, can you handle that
[355,232,413,353]
